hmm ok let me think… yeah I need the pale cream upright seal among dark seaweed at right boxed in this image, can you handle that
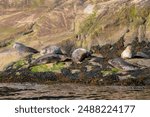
[121,45,133,59]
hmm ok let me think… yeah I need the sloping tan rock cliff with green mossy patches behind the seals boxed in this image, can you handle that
[0,0,150,70]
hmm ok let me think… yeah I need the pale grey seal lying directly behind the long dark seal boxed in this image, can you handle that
[40,46,64,55]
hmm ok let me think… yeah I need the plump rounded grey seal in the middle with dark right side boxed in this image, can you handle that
[72,48,91,63]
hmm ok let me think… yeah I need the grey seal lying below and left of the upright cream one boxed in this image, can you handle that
[108,58,140,71]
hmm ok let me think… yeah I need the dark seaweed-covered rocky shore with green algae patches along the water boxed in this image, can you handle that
[0,39,150,86]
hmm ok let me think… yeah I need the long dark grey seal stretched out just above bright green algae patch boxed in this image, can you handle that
[31,54,70,65]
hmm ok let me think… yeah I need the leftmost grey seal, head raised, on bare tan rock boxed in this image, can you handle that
[13,42,39,54]
